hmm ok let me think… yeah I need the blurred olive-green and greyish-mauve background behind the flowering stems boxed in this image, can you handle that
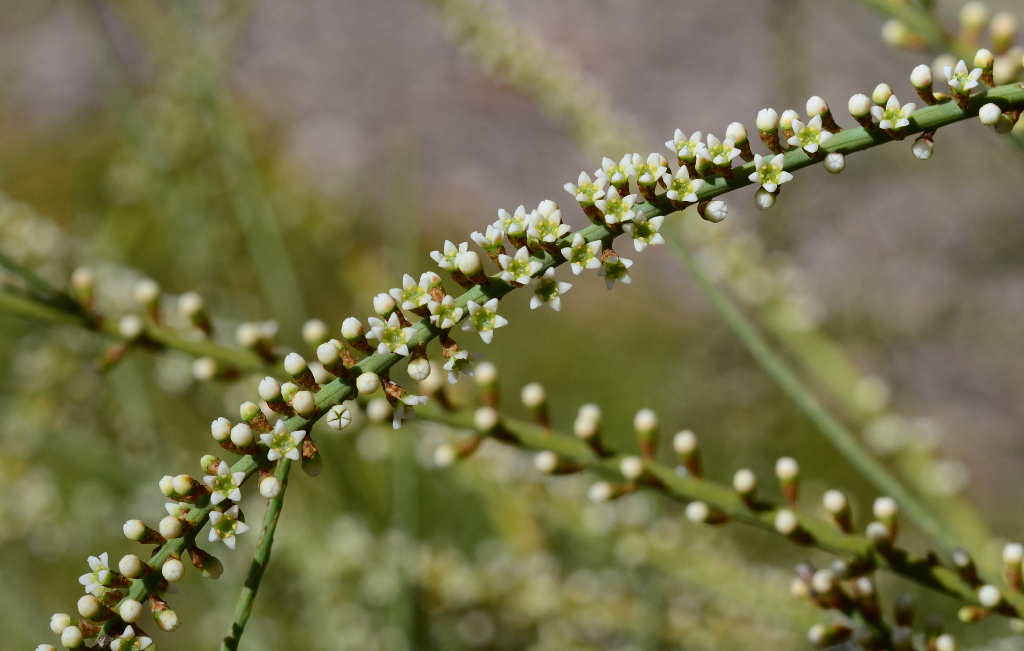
[0,0,1024,651]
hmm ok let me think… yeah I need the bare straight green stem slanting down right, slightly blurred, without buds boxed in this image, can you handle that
[671,235,957,552]
